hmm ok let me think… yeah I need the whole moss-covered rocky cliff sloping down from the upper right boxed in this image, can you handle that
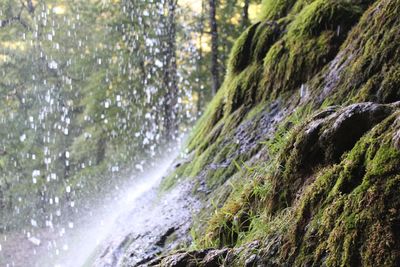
[119,0,400,266]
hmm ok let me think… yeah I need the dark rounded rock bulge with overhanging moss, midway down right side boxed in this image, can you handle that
[271,103,396,209]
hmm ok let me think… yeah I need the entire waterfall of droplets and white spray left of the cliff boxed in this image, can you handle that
[0,0,209,267]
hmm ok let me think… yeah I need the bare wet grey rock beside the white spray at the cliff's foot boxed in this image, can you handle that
[95,182,201,267]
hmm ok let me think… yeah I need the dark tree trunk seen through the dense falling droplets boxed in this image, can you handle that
[163,0,178,142]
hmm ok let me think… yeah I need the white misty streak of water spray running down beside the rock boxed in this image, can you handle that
[39,152,177,267]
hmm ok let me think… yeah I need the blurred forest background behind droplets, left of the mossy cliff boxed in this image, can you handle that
[0,0,260,232]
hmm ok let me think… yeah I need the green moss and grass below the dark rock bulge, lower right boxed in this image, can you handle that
[196,107,400,266]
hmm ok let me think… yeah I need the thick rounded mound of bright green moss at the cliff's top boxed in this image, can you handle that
[263,0,361,98]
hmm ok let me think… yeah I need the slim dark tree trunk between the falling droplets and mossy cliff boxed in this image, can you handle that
[209,0,220,95]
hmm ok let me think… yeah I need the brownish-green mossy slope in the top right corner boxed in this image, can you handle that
[317,0,400,107]
